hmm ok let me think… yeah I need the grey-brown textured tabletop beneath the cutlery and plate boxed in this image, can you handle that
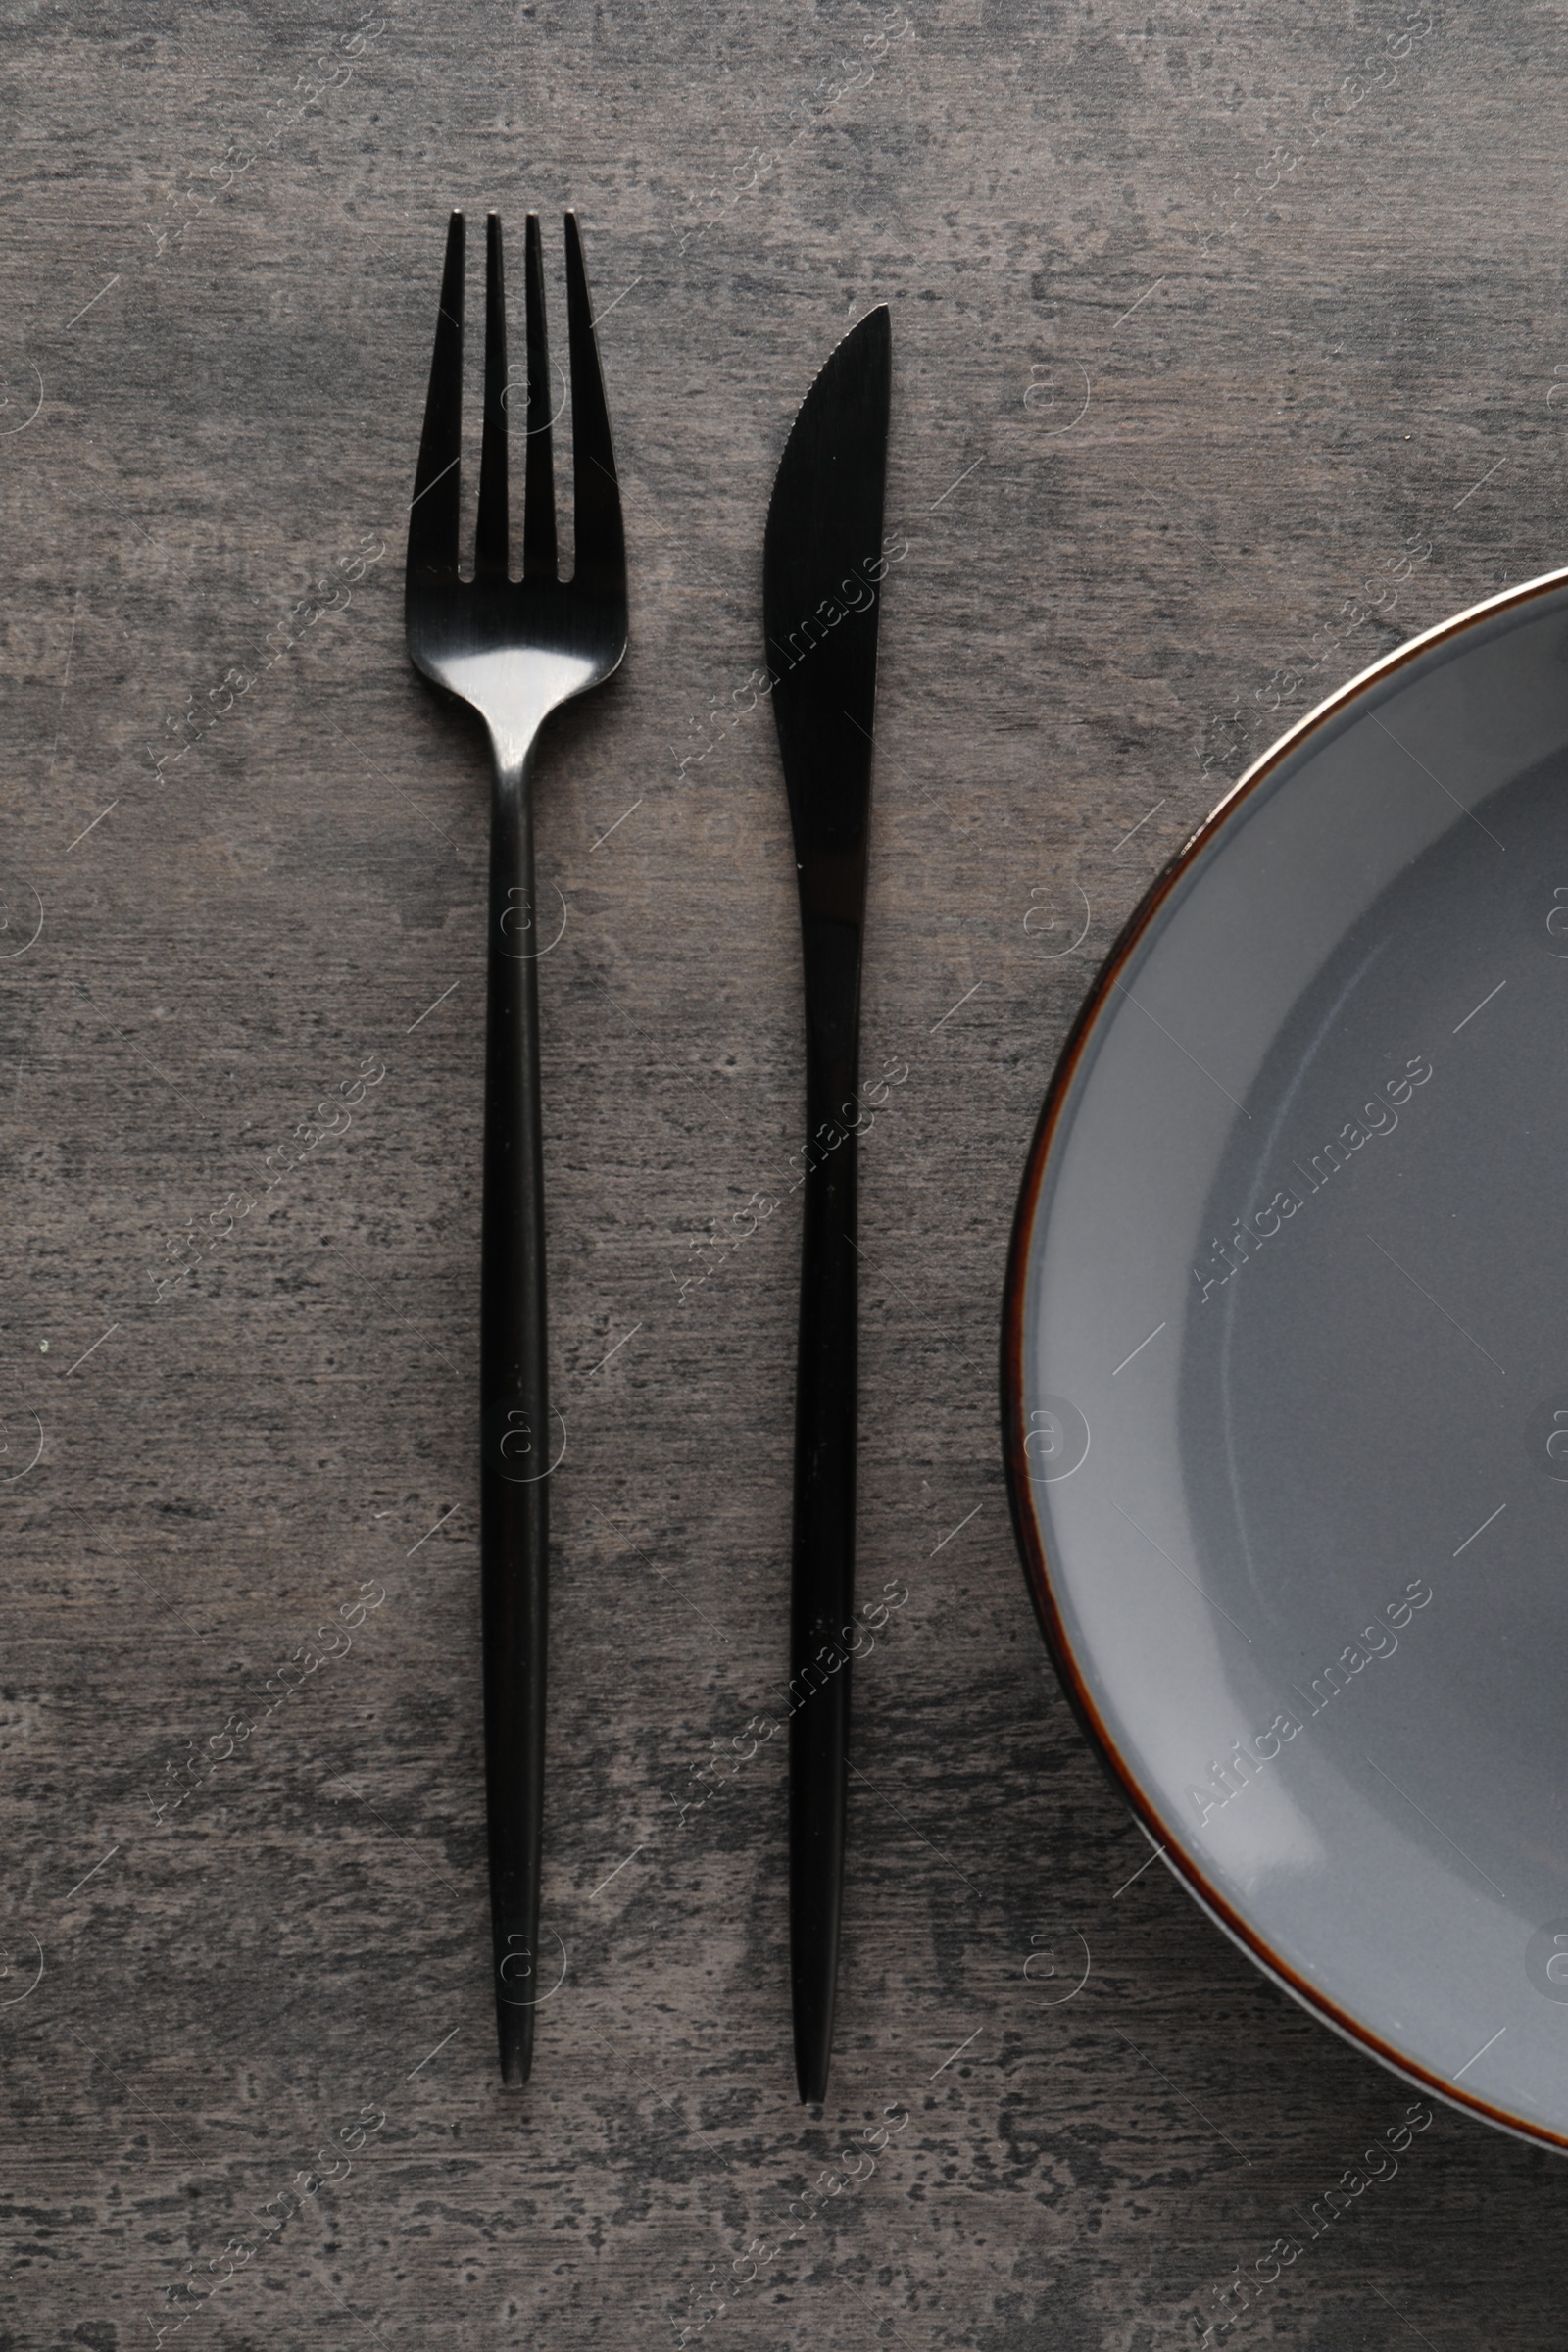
[0,0,1568,2352]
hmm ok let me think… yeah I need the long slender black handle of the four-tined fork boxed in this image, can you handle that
[479,755,555,2083]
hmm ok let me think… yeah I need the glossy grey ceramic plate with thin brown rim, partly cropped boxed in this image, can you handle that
[1004,571,1568,2145]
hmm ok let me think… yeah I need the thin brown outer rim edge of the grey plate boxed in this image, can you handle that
[999,550,1568,2152]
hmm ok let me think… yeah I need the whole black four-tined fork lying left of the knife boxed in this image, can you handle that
[405,212,625,2082]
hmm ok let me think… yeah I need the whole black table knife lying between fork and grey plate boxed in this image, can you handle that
[761,306,891,2103]
